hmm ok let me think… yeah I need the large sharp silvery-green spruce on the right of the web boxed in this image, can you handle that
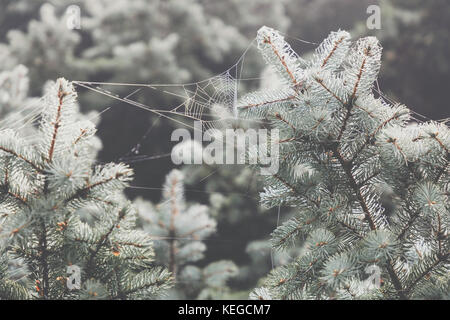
[243,27,450,299]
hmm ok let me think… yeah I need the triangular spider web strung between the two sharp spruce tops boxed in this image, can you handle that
[73,41,259,136]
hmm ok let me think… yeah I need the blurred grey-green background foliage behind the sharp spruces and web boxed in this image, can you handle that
[0,0,450,297]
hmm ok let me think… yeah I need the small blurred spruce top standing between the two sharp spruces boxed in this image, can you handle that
[135,170,237,299]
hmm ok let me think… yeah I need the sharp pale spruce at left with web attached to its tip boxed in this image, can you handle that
[0,79,170,299]
